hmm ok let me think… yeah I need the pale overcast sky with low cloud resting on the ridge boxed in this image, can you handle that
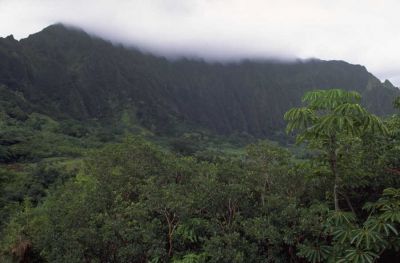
[0,0,400,86]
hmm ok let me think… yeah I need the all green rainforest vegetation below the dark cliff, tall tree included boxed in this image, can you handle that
[0,89,400,263]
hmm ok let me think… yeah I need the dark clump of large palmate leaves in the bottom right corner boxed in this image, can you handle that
[299,188,400,263]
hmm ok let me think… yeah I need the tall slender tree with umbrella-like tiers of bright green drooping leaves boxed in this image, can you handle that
[284,89,387,211]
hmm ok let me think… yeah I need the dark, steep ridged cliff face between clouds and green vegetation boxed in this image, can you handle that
[0,25,399,136]
